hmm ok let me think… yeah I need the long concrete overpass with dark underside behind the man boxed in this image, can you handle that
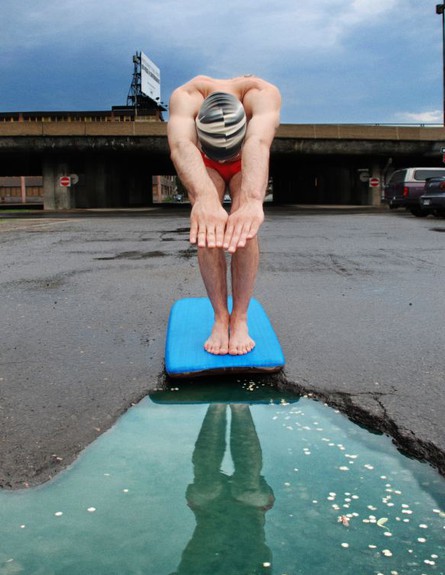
[0,112,445,209]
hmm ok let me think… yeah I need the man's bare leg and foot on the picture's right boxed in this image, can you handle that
[229,173,259,355]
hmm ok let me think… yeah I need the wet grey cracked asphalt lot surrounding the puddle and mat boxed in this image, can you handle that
[0,207,445,488]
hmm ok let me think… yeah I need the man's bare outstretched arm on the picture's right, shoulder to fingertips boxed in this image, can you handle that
[224,84,281,252]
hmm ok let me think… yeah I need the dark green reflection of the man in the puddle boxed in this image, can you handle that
[173,404,274,575]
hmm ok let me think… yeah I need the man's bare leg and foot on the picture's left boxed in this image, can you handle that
[198,168,229,355]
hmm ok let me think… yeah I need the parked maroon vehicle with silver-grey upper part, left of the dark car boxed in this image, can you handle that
[384,167,445,217]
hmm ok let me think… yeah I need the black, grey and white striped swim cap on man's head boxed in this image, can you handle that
[196,92,246,162]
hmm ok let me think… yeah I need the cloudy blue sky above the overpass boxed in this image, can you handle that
[0,0,443,124]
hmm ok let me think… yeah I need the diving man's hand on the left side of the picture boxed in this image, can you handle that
[190,199,229,248]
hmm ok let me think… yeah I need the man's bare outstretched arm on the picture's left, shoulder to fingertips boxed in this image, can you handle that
[167,88,228,247]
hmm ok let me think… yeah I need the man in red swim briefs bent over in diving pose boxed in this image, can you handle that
[168,76,281,355]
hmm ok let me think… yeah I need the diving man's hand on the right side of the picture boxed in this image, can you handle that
[223,200,264,254]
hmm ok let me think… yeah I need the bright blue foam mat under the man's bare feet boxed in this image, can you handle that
[165,298,285,377]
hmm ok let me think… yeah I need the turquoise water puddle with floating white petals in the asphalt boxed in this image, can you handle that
[0,381,445,575]
